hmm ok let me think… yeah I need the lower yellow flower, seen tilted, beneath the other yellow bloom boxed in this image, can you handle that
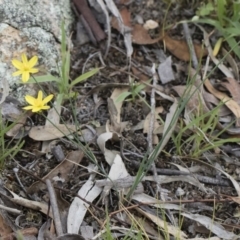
[23,91,53,112]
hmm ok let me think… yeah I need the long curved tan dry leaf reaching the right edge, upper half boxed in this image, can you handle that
[204,79,240,127]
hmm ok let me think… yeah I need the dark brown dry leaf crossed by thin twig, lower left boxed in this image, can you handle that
[27,150,84,194]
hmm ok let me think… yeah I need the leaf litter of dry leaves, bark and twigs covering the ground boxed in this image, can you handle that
[1,0,240,240]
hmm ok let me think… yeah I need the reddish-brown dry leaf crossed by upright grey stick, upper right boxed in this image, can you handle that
[163,33,208,61]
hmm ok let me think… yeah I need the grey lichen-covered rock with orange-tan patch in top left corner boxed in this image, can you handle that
[0,0,74,101]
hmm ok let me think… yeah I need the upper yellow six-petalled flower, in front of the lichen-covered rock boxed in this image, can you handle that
[12,53,38,83]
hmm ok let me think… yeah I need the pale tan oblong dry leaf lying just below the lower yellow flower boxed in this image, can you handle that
[29,124,77,141]
